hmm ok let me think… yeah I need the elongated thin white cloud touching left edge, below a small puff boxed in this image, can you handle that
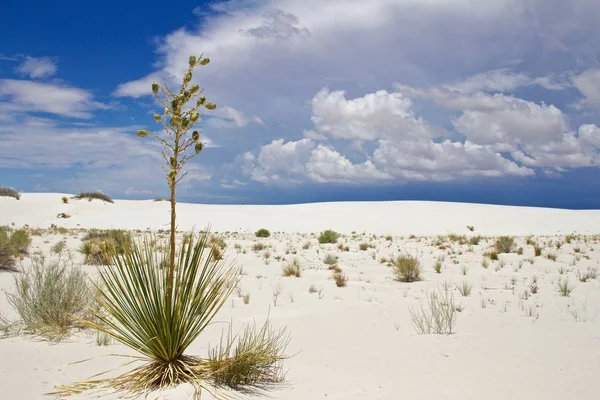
[0,79,109,119]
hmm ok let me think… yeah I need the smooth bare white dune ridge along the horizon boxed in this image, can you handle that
[0,193,600,235]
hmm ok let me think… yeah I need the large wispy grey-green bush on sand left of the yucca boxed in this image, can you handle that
[7,256,94,340]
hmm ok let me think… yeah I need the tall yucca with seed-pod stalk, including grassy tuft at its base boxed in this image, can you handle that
[54,56,288,398]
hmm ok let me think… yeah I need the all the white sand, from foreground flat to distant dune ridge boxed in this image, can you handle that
[0,193,600,400]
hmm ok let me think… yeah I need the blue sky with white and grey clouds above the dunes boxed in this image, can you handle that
[0,0,600,208]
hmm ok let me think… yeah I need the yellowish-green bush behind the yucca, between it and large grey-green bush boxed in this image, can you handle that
[79,229,133,265]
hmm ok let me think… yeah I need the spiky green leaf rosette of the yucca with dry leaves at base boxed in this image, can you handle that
[56,233,239,395]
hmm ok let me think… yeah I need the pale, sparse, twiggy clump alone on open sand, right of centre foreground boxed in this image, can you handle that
[410,285,459,335]
